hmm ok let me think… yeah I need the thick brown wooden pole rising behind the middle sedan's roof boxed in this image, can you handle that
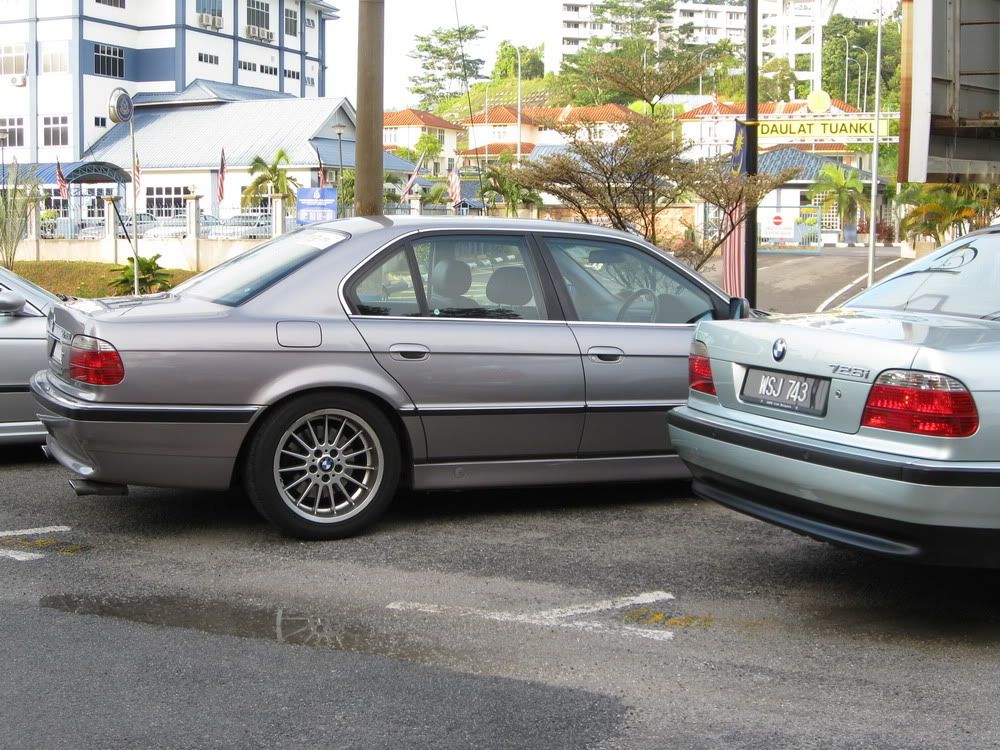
[354,0,385,216]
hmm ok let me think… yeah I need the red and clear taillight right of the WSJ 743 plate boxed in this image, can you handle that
[861,370,979,437]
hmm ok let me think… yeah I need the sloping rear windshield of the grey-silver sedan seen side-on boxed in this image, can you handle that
[173,227,348,307]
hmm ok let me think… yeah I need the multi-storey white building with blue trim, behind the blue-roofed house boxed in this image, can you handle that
[0,0,336,164]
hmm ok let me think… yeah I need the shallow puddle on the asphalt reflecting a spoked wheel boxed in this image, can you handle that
[39,594,442,663]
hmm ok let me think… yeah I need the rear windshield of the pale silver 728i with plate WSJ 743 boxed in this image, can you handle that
[844,239,1000,320]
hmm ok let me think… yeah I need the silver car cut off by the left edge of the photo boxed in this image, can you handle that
[0,267,59,444]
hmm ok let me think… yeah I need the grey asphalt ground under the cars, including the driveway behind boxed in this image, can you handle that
[0,254,1000,748]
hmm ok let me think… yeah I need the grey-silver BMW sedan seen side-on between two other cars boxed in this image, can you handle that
[33,217,741,538]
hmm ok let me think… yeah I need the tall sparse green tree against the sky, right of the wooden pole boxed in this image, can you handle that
[410,25,485,109]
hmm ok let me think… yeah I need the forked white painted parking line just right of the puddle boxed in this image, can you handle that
[386,591,674,641]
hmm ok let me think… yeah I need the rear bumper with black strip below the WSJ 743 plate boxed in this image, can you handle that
[669,407,1000,567]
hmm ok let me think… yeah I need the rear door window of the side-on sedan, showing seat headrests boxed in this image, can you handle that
[413,234,548,320]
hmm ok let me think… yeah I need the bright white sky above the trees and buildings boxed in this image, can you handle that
[326,0,898,110]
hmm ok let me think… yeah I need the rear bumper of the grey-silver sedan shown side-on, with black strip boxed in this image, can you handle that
[31,371,257,489]
